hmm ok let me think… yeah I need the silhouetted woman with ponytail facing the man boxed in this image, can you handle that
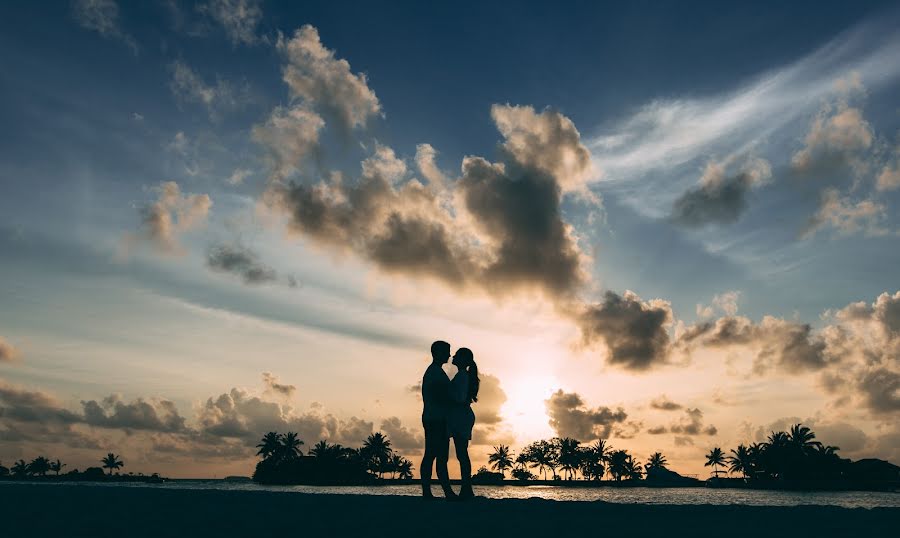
[447,347,480,499]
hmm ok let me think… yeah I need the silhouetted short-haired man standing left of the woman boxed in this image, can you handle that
[419,340,456,499]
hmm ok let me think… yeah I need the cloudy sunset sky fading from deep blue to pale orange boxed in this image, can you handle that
[0,0,900,477]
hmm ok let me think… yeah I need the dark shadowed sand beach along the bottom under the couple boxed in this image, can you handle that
[0,484,900,538]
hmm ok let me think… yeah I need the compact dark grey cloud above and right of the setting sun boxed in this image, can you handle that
[579,291,673,371]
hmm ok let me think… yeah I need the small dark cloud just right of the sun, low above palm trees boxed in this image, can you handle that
[545,389,628,441]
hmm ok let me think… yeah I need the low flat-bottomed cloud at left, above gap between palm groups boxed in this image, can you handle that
[81,394,187,432]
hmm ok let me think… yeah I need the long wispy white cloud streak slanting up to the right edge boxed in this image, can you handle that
[587,16,900,180]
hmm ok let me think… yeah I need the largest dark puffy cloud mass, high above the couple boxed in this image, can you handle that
[266,102,593,298]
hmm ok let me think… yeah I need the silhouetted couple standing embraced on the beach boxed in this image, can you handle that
[419,340,479,500]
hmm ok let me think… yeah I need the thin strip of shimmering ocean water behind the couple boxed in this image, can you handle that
[0,480,900,508]
